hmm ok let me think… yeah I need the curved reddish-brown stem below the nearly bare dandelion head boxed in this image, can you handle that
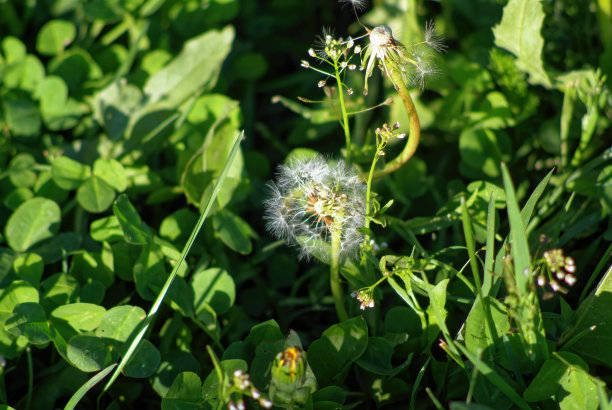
[374,62,421,179]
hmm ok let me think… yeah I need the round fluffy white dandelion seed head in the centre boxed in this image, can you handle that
[265,156,366,263]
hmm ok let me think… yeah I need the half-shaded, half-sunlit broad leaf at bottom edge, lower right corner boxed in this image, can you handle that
[523,352,599,410]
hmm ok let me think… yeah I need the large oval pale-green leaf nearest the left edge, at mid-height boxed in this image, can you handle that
[4,198,61,252]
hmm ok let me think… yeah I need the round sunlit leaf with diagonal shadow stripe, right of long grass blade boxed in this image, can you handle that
[191,268,236,315]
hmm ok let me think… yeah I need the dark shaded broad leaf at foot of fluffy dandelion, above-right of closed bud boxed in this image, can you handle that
[308,316,368,386]
